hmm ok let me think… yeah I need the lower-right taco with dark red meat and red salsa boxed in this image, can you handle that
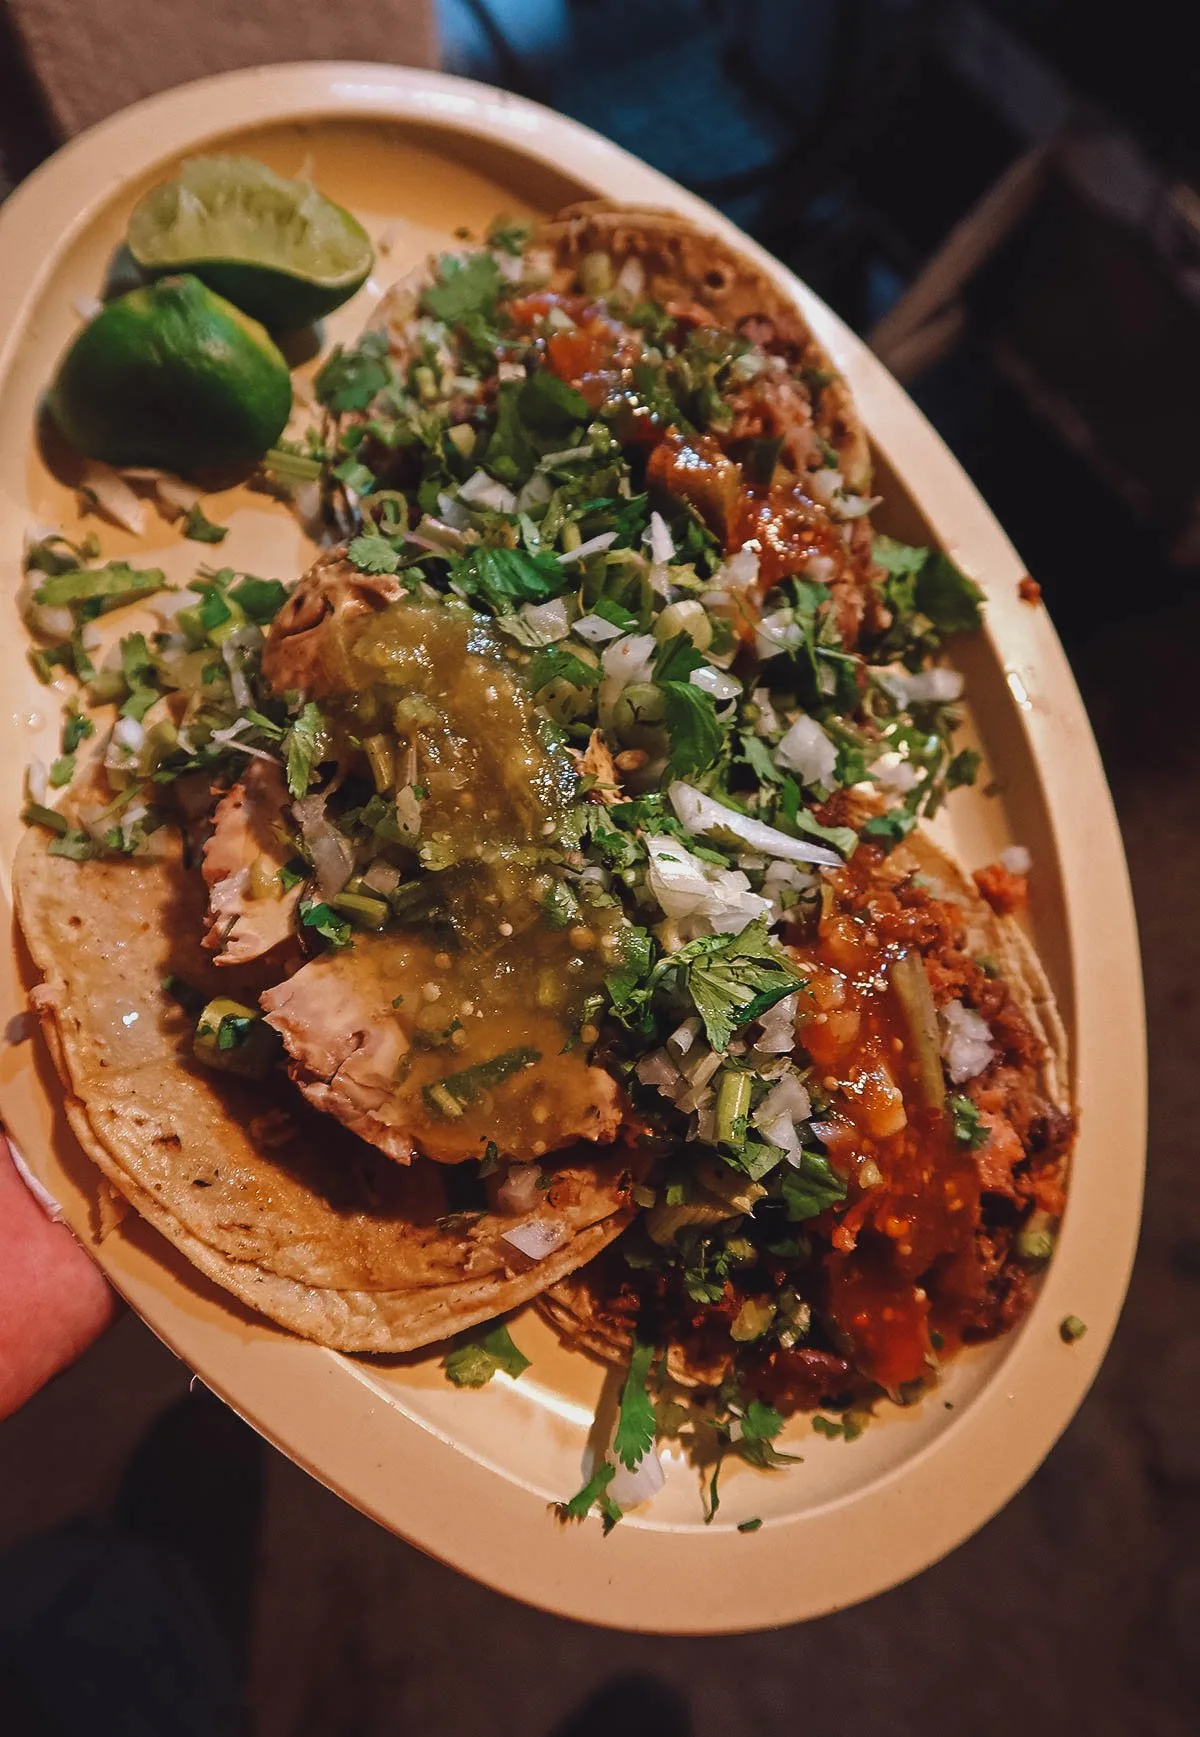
[538,819,1075,1412]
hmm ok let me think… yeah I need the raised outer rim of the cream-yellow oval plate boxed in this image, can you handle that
[0,61,1146,1635]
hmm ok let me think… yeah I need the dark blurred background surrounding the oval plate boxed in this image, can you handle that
[0,0,1200,1737]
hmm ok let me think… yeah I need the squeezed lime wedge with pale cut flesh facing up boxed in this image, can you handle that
[127,156,375,332]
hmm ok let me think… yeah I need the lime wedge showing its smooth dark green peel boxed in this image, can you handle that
[49,278,292,476]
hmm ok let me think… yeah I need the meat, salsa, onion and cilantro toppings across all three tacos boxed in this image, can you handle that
[19,207,1071,1511]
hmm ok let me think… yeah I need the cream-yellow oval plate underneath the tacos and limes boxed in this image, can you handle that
[0,54,1144,1633]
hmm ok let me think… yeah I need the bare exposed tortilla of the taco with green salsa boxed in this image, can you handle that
[14,830,634,1351]
